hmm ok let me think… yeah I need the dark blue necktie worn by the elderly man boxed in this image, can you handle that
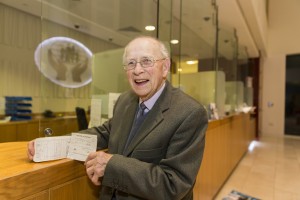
[124,103,147,151]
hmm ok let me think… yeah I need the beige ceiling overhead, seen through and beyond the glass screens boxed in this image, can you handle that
[0,0,259,57]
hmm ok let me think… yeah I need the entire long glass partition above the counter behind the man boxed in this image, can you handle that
[0,0,247,140]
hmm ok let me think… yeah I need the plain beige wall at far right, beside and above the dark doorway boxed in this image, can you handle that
[260,0,300,135]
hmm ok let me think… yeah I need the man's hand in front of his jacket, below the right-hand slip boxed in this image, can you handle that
[85,151,113,185]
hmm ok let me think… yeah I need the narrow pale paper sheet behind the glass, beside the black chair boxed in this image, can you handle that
[89,95,102,128]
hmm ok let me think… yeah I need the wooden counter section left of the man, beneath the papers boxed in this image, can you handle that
[0,142,98,200]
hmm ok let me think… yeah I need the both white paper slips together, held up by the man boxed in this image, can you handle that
[33,133,97,162]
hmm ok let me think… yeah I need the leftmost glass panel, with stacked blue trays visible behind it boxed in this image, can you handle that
[0,1,41,142]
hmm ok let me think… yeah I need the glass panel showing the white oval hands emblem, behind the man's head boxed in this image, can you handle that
[38,0,171,135]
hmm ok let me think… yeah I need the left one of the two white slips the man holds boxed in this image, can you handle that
[33,136,71,162]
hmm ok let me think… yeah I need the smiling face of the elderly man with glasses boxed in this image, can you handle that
[125,38,169,101]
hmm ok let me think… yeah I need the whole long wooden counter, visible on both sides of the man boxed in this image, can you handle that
[0,114,255,200]
